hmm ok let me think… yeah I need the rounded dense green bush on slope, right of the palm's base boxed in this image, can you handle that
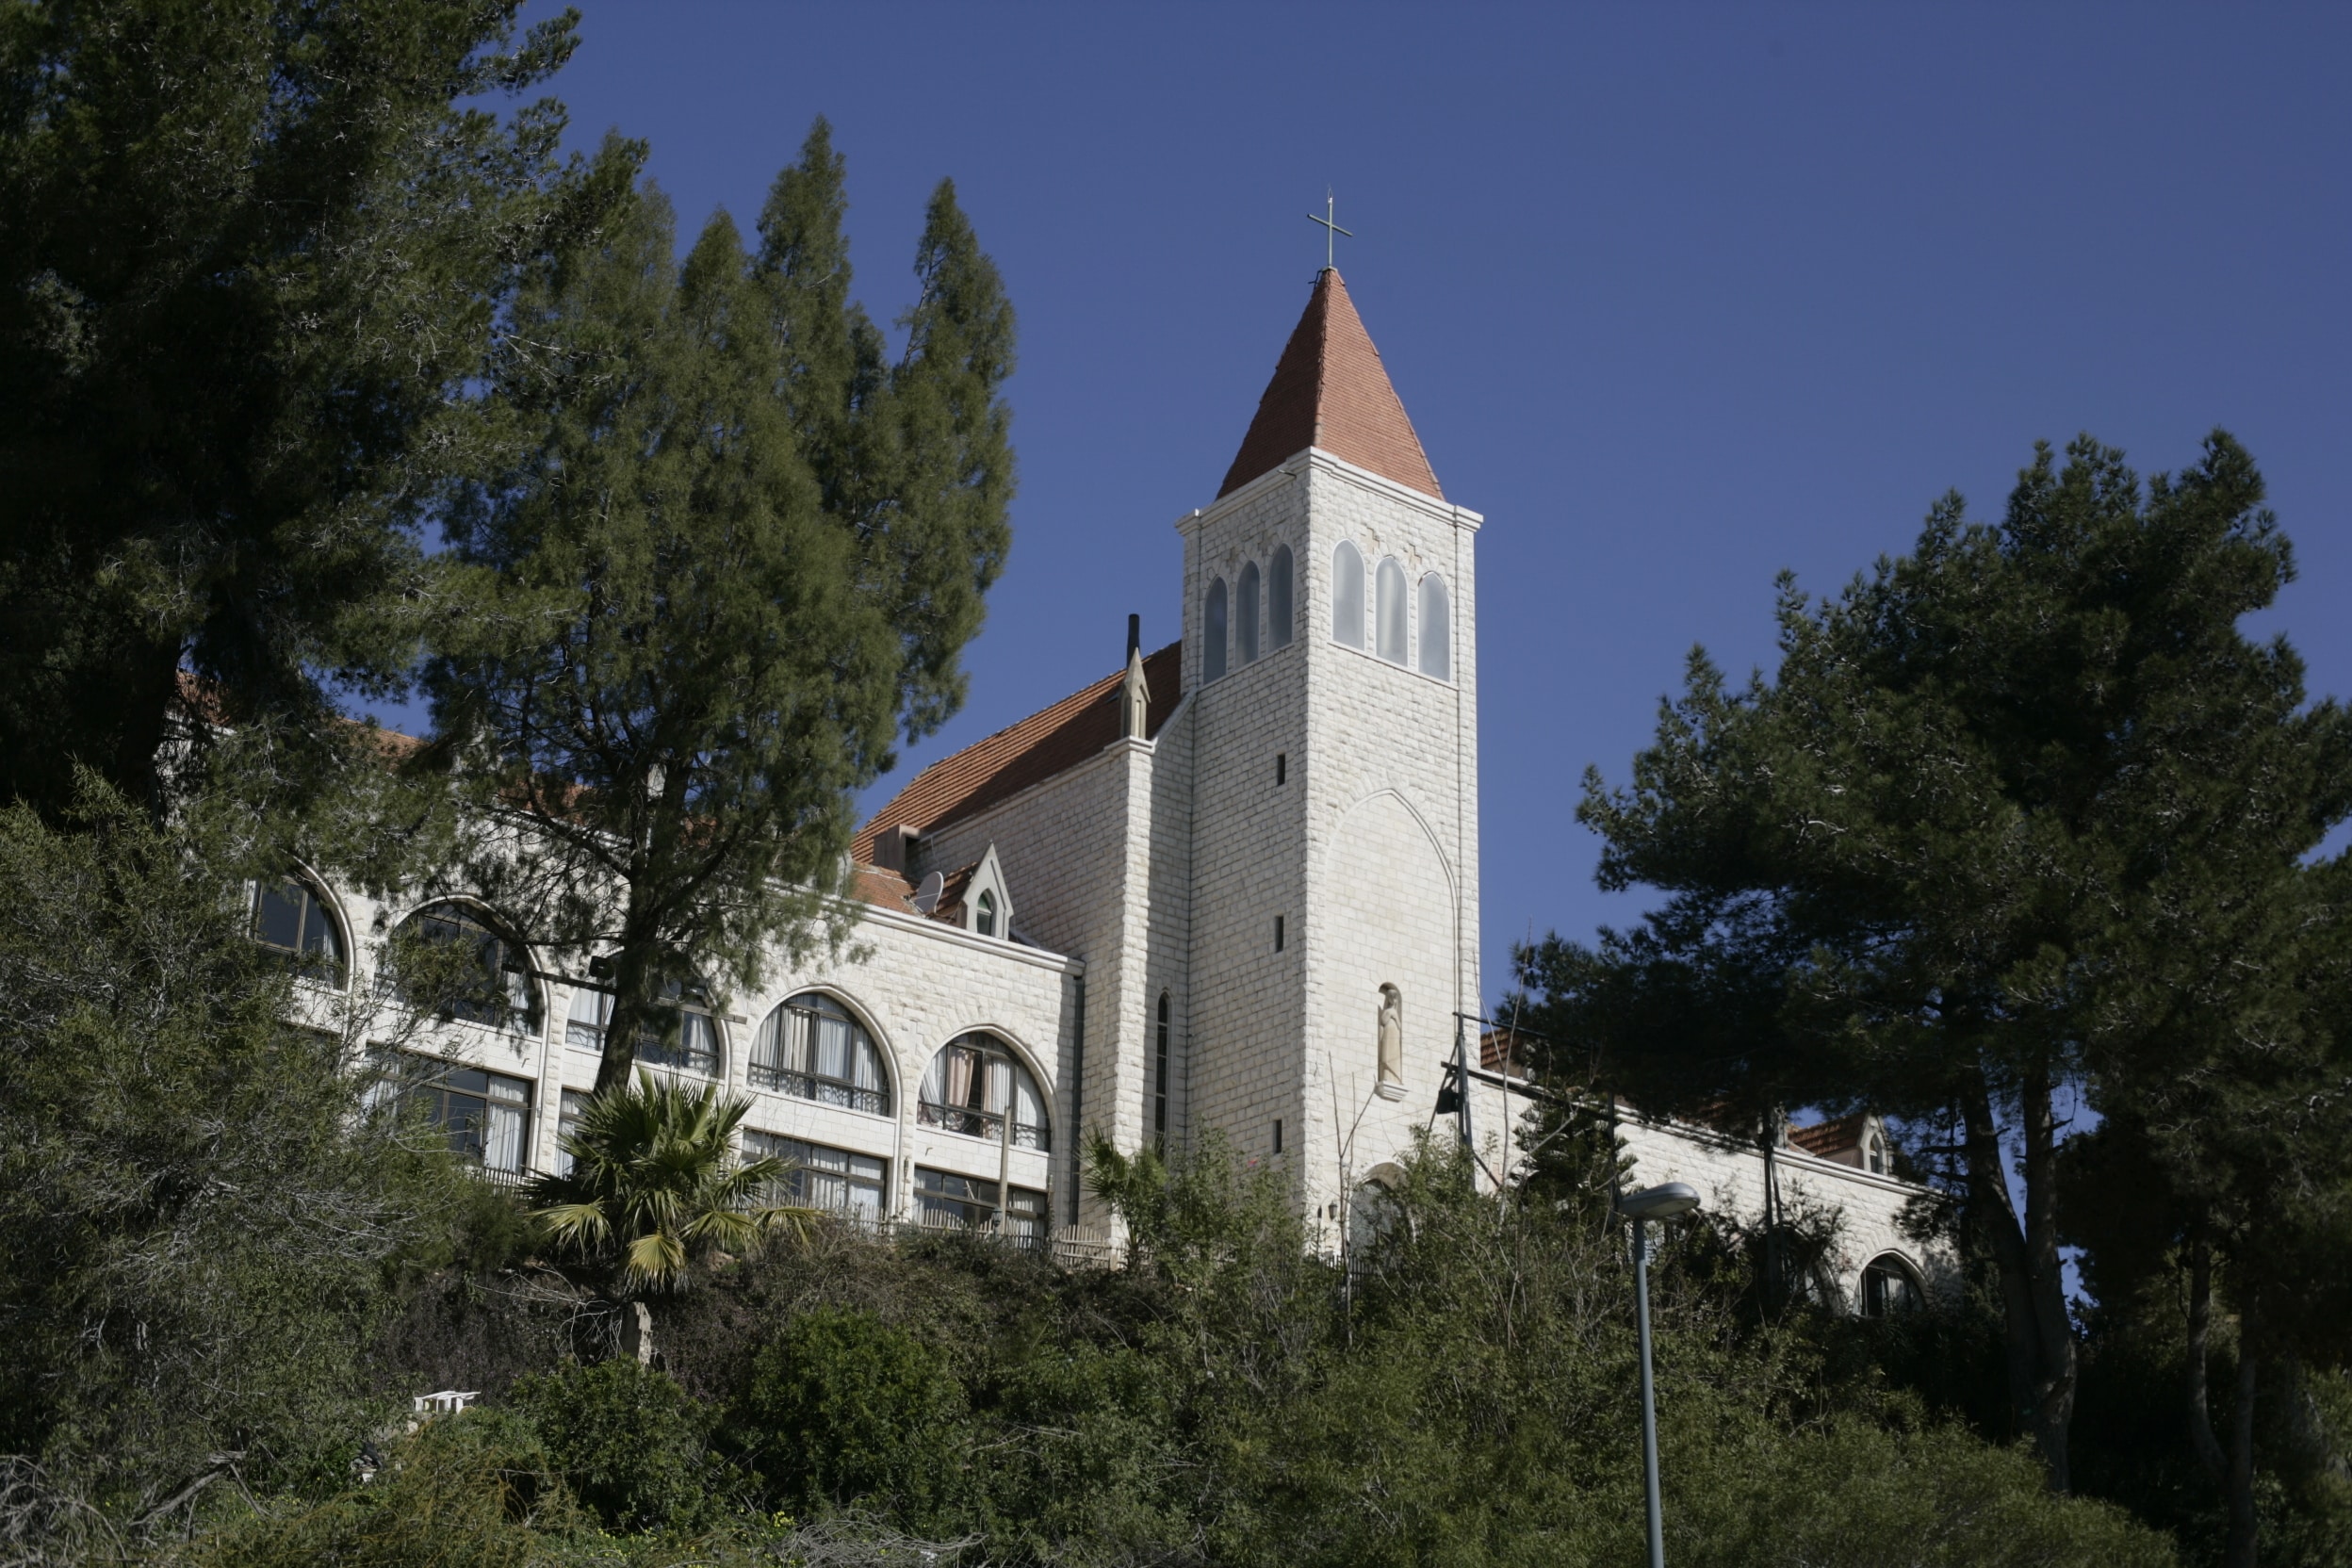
[729,1310,967,1528]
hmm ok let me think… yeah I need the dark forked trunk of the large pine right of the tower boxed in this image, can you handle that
[1962,1072,2074,1493]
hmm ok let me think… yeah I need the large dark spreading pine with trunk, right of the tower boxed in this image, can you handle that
[1524,433,2352,1488]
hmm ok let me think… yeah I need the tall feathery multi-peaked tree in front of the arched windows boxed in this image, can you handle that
[428,122,1011,1088]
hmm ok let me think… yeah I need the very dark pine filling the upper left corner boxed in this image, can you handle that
[0,0,599,816]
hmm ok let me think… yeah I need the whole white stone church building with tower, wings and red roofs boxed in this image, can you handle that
[256,268,1948,1305]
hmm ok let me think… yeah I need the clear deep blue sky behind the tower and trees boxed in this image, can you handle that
[496,0,2352,997]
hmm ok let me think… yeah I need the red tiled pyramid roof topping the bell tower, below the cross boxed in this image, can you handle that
[1216,268,1445,500]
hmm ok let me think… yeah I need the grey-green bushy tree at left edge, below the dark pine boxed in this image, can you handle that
[0,785,466,1519]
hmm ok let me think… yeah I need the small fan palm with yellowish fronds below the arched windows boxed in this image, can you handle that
[531,1070,816,1359]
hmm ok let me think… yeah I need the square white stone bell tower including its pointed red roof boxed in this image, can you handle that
[1176,266,1481,1213]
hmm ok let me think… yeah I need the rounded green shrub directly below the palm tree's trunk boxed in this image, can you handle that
[508,1356,715,1530]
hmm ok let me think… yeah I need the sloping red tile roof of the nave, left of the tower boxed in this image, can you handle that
[852,642,1183,882]
